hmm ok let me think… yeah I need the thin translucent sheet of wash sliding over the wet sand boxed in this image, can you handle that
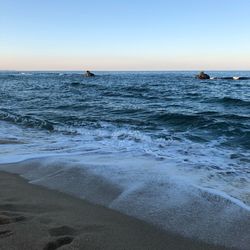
[1,154,250,250]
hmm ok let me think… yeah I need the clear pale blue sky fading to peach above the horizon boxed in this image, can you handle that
[0,0,250,71]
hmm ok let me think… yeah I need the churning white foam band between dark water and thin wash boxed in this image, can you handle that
[0,122,250,205]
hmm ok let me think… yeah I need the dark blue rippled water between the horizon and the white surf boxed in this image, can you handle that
[0,72,250,146]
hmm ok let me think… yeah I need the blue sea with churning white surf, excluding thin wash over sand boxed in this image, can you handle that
[0,72,250,204]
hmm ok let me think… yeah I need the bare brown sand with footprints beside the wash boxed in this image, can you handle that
[0,172,232,250]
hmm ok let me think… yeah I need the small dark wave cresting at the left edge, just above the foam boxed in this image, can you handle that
[0,111,54,131]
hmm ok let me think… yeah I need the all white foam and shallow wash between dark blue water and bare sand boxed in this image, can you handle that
[0,122,250,249]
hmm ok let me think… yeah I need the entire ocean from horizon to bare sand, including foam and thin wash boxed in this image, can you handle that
[0,71,250,247]
